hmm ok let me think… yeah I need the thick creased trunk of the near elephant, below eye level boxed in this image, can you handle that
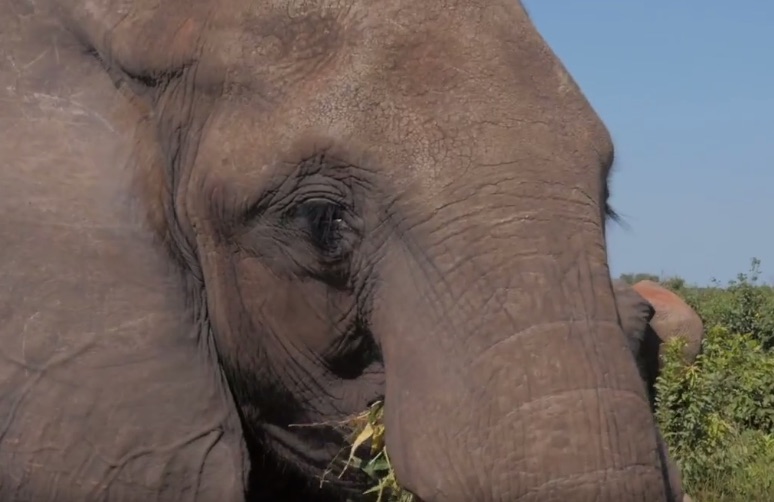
[380,207,671,502]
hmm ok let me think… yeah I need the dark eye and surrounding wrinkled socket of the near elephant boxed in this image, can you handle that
[226,148,378,291]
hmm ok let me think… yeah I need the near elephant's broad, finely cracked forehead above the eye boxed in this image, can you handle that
[174,0,612,198]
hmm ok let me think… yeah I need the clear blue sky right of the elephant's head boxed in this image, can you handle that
[524,0,774,284]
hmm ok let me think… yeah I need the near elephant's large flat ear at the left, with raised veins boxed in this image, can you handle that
[0,11,252,502]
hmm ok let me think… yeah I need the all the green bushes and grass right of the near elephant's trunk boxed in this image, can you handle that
[656,259,774,502]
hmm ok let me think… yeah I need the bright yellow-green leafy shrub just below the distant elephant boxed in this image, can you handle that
[656,326,774,486]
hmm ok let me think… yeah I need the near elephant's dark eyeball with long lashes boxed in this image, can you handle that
[294,199,351,261]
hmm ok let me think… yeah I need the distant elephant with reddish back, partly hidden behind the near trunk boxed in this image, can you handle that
[613,279,704,409]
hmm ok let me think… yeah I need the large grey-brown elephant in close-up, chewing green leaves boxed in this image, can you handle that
[0,0,681,502]
